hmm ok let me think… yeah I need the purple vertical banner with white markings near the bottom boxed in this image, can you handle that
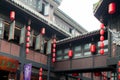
[24,63,32,80]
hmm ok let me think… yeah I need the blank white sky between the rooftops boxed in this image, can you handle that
[59,0,100,32]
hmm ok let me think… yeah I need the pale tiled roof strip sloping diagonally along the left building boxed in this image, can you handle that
[7,0,72,36]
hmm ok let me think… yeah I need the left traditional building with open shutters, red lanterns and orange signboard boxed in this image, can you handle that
[0,0,87,80]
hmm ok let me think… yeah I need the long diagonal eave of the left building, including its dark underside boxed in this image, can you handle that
[2,0,72,38]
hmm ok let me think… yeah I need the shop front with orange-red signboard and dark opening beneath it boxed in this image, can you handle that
[0,55,19,80]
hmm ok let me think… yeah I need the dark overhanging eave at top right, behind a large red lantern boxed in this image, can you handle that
[94,0,120,25]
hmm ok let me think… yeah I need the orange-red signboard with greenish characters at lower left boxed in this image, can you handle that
[0,56,19,72]
